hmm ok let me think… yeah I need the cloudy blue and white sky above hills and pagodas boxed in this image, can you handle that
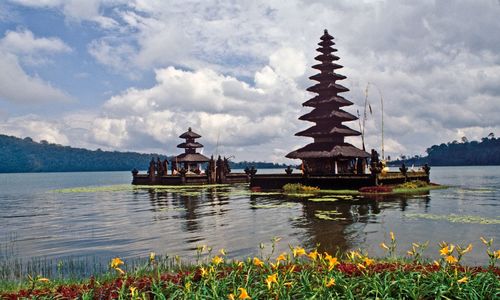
[0,0,500,163]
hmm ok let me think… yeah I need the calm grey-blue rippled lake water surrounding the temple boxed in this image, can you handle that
[0,166,500,278]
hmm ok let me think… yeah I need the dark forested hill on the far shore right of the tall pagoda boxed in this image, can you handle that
[391,133,500,166]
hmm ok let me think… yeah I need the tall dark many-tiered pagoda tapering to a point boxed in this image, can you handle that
[286,30,370,175]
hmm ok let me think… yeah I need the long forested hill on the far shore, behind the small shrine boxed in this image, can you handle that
[0,134,285,173]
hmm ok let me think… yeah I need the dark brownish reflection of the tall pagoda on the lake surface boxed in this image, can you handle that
[298,192,430,253]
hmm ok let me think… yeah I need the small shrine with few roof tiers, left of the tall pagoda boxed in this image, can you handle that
[172,127,210,174]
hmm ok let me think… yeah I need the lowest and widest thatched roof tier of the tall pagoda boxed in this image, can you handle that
[286,142,370,159]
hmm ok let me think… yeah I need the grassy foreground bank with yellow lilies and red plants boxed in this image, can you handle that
[0,233,500,299]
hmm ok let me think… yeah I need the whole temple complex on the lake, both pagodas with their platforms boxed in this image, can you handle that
[133,30,430,189]
